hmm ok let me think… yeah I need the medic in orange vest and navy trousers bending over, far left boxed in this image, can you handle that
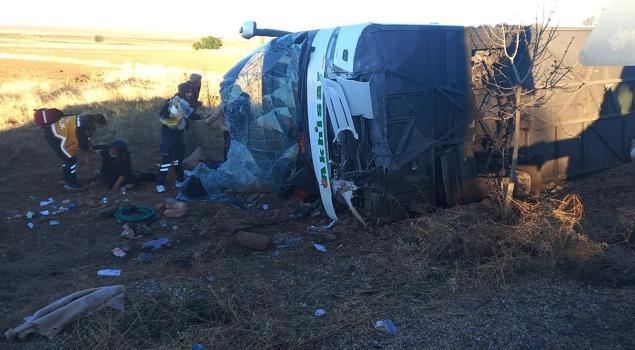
[44,114,106,191]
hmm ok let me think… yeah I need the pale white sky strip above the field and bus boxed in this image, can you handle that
[0,0,610,36]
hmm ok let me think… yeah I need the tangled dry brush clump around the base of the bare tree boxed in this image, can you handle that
[414,194,605,284]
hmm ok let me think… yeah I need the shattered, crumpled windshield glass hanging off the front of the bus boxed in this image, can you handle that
[183,33,306,200]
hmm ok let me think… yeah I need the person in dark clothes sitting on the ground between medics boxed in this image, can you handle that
[93,140,156,192]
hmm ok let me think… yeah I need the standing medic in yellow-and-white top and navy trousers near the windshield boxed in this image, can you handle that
[156,81,195,193]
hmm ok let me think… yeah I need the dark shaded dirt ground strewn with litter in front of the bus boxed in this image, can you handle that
[0,144,635,349]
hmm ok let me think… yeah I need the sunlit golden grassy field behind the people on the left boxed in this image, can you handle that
[0,28,261,165]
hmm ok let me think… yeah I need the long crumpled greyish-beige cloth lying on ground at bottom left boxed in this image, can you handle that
[4,285,125,341]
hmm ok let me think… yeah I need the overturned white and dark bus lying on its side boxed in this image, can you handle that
[188,22,635,220]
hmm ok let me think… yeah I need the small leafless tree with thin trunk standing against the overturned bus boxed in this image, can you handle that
[470,9,573,211]
